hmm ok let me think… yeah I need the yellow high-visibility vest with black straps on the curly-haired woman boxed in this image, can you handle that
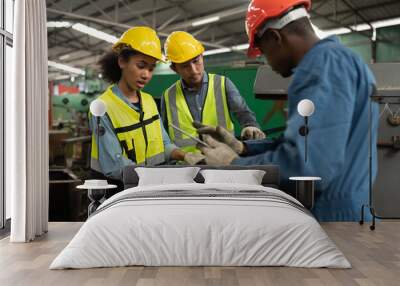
[91,86,165,172]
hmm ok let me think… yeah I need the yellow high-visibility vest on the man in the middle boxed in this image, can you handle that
[164,74,234,152]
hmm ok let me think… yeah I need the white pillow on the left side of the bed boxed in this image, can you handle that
[135,167,200,186]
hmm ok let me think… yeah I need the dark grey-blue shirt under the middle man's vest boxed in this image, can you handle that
[160,72,260,128]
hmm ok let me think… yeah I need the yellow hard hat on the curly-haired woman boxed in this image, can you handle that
[112,27,163,61]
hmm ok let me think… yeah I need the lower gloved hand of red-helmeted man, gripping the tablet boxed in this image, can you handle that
[197,135,239,166]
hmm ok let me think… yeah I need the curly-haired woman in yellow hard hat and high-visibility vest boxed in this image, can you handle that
[90,27,202,180]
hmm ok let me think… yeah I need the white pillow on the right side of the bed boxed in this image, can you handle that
[200,169,265,185]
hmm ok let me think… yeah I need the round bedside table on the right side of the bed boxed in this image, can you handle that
[289,177,321,210]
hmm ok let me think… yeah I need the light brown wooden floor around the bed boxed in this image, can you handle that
[0,221,400,286]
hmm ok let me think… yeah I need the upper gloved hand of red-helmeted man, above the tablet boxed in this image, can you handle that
[193,121,244,155]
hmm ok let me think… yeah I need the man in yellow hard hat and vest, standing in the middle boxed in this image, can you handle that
[161,31,265,154]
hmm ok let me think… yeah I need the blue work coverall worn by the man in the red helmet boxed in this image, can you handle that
[233,37,379,221]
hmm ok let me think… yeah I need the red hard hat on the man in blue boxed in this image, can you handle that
[246,0,311,58]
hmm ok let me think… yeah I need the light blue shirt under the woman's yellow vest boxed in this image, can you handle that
[89,85,178,179]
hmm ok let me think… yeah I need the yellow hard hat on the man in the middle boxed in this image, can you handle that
[164,31,204,64]
